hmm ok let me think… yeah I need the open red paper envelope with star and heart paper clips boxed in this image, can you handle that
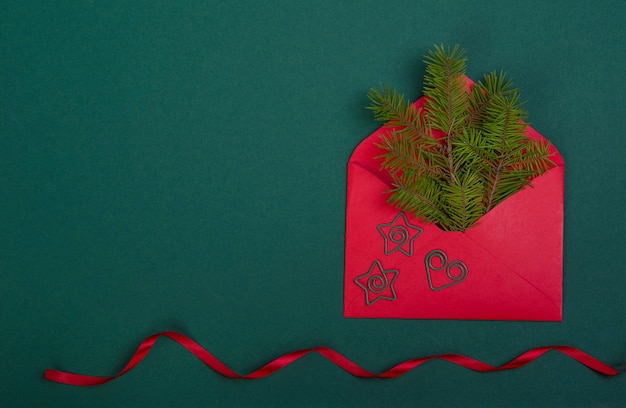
[344,93,564,321]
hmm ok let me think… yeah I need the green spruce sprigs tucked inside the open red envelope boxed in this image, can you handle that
[368,45,555,231]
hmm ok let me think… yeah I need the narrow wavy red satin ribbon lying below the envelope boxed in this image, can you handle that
[45,332,620,386]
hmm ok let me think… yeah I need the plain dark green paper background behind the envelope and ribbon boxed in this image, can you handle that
[0,0,626,407]
